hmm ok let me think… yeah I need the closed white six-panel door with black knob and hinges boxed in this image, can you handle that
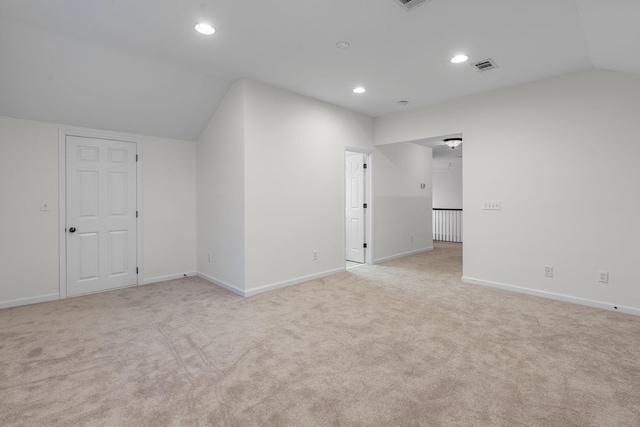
[65,135,138,296]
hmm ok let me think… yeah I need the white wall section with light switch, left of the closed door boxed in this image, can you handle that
[0,117,59,307]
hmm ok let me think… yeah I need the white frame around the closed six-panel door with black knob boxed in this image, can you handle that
[58,129,144,299]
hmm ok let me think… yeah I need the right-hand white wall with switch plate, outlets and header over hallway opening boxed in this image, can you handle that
[376,70,640,314]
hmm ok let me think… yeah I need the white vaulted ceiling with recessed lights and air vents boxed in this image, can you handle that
[0,0,640,140]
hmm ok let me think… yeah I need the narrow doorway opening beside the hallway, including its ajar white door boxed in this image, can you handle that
[345,149,371,268]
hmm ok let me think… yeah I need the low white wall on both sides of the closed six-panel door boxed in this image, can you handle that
[0,113,195,307]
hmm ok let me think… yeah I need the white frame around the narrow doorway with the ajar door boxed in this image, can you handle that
[342,146,375,264]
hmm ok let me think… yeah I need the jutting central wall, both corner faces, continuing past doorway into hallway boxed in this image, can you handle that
[198,80,432,295]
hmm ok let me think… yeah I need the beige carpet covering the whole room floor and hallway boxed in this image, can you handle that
[0,244,640,426]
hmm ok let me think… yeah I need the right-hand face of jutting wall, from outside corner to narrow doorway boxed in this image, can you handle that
[245,81,373,291]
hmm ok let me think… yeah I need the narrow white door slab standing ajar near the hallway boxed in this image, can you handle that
[345,152,365,263]
